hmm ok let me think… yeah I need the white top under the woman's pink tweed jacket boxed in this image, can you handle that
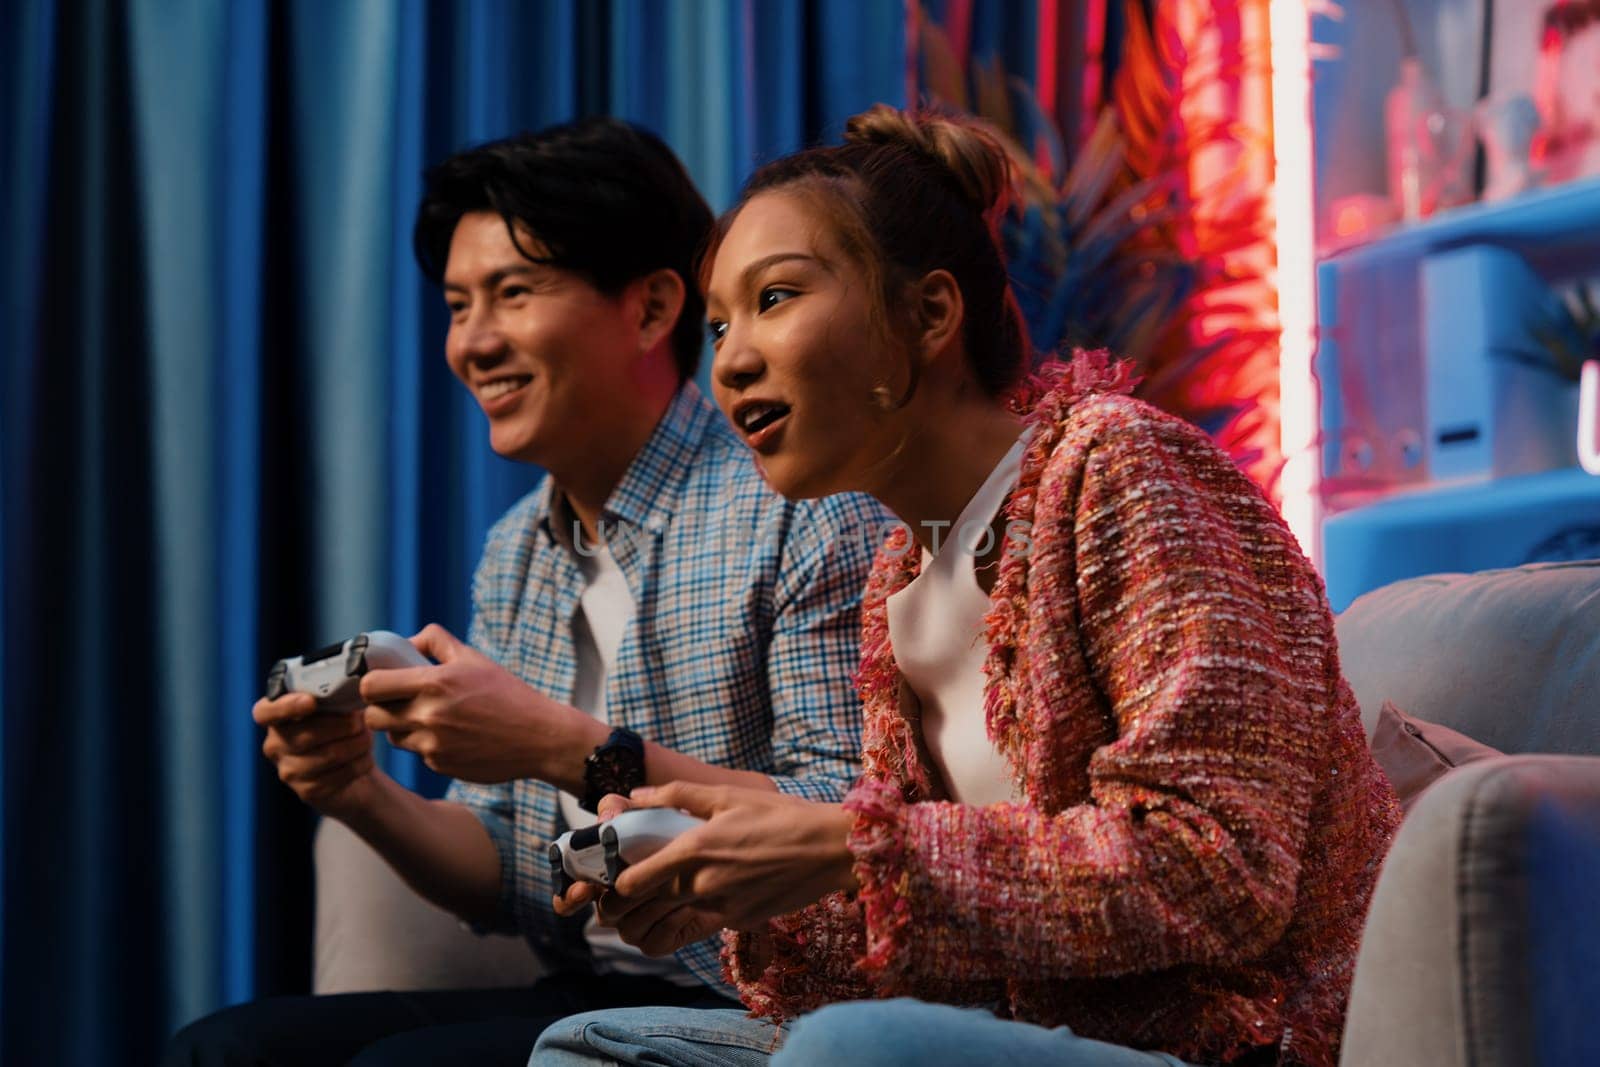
[886,432,1027,805]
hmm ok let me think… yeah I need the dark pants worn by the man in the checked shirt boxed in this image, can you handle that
[162,974,738,1067]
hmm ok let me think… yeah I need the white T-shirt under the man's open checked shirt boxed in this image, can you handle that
[560,518,701,985]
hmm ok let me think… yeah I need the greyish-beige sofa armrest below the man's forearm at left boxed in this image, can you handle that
[312,819,541,993]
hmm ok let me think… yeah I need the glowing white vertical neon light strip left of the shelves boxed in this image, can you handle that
[1269,0,1322,568]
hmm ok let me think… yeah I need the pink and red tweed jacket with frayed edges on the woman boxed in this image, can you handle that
[725,354,1400,1067]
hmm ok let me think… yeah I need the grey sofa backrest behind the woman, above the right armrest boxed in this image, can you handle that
[1338,560,1600,755]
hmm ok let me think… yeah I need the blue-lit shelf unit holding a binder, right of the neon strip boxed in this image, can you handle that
[1315,179,1600,608]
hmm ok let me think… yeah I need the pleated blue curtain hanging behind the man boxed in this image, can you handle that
[0,0,906,1064]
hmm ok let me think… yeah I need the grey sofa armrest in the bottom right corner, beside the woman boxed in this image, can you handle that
[1339,755,1600,1067]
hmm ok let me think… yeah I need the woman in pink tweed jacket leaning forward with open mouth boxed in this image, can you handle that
[536,107,1398,1067]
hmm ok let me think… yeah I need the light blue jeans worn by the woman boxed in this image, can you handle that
[528,1000,1186,1067]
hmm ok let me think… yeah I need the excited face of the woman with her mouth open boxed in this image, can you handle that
[706,190,909,499]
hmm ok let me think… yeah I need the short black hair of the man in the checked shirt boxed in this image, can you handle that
[411,118,712,379]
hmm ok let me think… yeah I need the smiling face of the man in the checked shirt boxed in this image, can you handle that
[445,211,638,469]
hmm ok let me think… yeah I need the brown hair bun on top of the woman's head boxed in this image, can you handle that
[845,104,1011,218]
